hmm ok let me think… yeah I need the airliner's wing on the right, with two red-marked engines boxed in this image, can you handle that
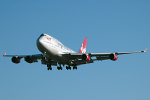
[62,49,147,65]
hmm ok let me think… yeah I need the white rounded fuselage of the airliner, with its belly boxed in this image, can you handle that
[37,34,76,63]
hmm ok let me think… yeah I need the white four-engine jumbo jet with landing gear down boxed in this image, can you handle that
[3,33,147,70]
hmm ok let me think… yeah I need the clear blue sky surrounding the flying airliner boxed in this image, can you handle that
[0,0,150,100]
